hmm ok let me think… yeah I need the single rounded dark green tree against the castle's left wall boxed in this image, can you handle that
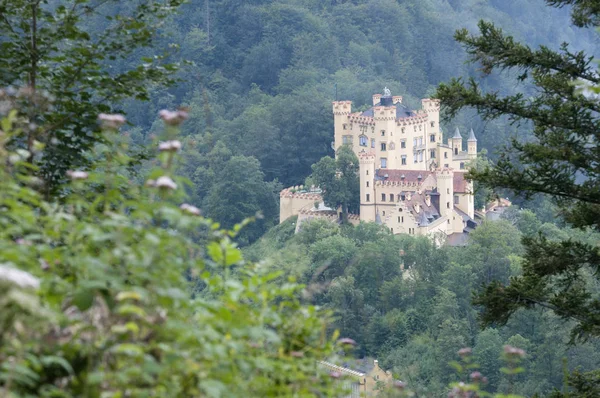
[312,146,360,222]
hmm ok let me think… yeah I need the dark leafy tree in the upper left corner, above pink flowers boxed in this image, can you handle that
[0,0,184,192]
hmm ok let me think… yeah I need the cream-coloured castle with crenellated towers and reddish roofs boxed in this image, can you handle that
[280,88,477,244]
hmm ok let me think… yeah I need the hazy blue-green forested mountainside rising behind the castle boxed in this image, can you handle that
[118,0,597,241]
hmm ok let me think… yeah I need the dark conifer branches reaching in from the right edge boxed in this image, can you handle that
[437,0,600,338]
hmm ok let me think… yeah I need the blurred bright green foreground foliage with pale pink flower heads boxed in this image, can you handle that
[0,107,339,397]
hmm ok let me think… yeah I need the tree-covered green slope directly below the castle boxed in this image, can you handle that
[245,209,600,397]
